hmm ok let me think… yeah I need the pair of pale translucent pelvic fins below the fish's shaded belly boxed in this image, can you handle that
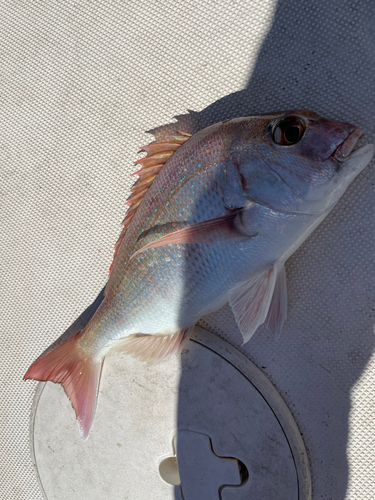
[229,264,286,343]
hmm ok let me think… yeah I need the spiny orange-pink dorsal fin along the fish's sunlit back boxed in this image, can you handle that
[109,132,191,274]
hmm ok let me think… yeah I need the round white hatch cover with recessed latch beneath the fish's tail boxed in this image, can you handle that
[31,328,311,500]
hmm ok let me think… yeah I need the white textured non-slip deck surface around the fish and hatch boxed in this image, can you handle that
[0,0,375,500]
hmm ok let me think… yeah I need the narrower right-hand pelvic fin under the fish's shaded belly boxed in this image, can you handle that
[265,265,288,340]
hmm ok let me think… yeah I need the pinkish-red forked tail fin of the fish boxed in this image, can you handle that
[23,332,103,440]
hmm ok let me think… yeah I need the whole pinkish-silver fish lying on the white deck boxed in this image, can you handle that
[24,109,374,440]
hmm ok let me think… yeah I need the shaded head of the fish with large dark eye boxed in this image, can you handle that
[231,110,374,214]
